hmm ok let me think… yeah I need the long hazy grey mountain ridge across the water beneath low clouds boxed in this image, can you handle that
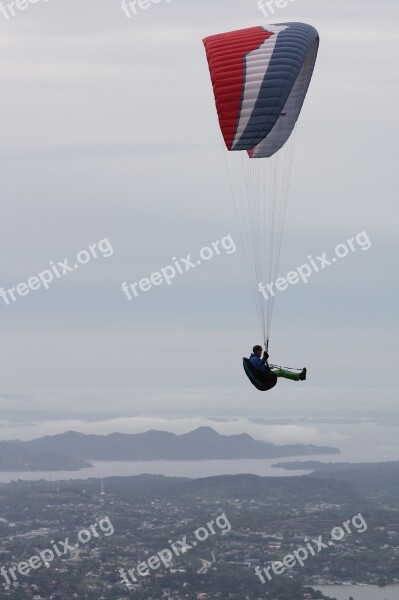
[25,427,340,461]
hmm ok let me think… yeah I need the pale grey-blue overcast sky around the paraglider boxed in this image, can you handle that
[0,0,399,432]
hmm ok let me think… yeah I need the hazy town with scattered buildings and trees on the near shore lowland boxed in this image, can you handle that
[0,476,399,600]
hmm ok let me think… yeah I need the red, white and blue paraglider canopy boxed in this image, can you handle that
[204,23,319,158]
